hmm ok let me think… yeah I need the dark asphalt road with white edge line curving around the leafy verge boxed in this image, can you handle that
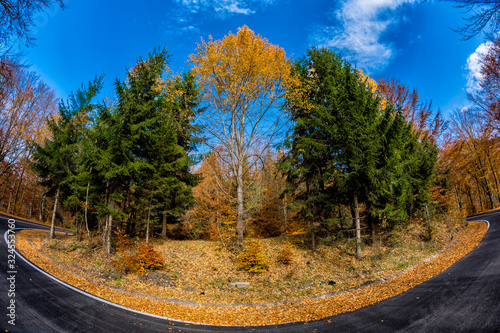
[0,212,500,333]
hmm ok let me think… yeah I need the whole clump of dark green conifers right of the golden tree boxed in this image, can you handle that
[282,48,436,258]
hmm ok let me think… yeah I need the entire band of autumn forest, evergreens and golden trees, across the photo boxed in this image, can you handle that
[0,21,500,259]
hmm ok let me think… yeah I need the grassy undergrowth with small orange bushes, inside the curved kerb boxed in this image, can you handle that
[35,215,463,304]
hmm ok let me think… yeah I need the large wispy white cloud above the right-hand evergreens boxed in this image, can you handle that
[313,0,415,73]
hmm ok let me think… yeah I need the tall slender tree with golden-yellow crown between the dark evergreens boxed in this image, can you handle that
[190,26,291,250]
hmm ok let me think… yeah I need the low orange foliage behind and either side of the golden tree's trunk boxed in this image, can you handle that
[184,149,294,245]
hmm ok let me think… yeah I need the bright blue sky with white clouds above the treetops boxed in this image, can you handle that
[25,0,487,116]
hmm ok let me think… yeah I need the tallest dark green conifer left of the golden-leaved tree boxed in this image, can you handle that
[95,49,197,255]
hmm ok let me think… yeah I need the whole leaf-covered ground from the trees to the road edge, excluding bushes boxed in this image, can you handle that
[17,220,486,326]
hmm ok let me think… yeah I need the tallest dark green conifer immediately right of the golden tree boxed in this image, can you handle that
[283,48,379,254]
